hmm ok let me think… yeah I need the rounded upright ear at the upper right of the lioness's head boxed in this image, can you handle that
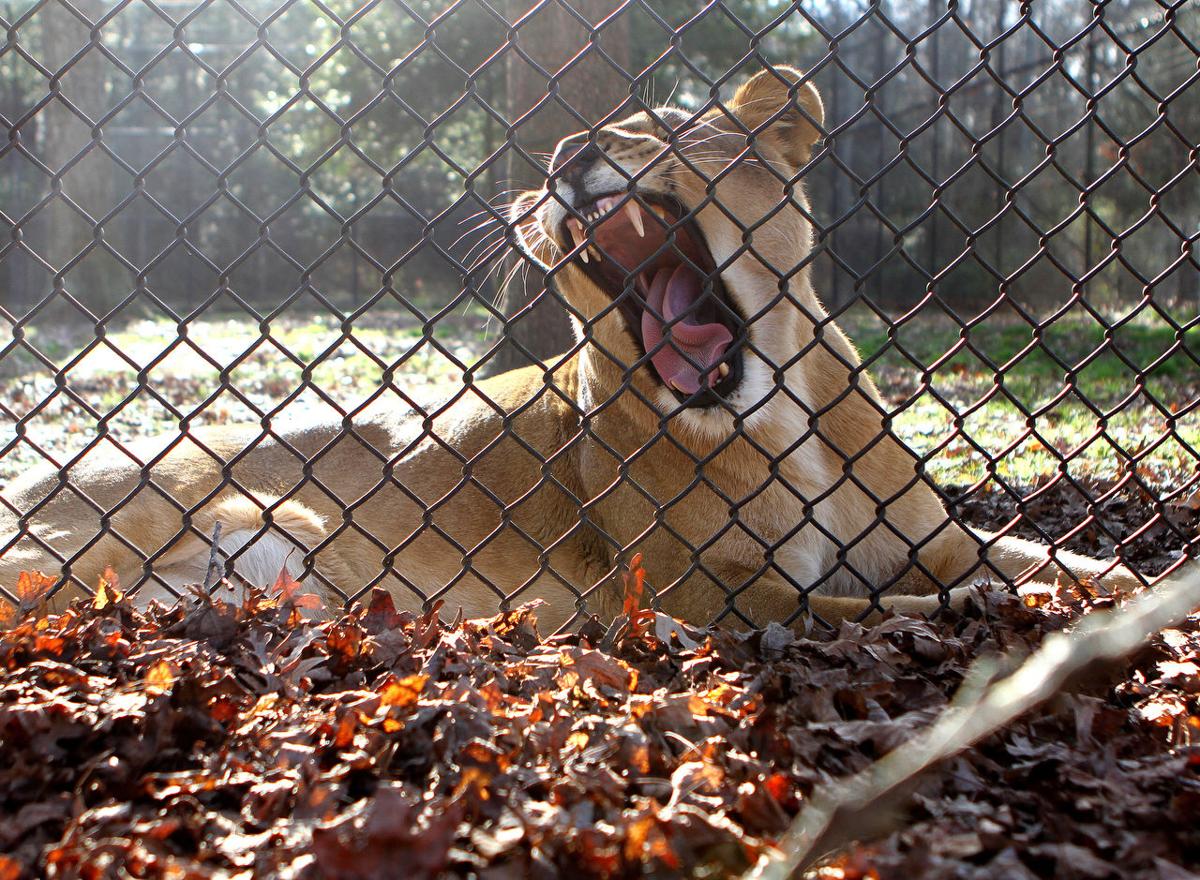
[730,67,824,168]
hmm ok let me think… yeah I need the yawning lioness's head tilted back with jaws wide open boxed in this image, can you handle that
[510,67,823,427]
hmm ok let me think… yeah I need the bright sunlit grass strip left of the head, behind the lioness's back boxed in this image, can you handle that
[0,304,487,486]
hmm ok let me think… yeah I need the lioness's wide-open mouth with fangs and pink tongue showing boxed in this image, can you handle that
[564,193,744,406]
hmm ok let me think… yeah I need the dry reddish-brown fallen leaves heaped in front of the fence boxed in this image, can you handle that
[0,581,1200,880]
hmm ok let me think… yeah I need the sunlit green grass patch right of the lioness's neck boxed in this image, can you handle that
[840,304,1200,485]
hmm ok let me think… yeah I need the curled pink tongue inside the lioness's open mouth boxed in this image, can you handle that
[642,263,733,394]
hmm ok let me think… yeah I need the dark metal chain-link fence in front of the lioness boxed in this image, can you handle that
[0,0,1200,625]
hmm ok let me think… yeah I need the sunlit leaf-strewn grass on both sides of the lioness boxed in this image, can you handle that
[0,302,1200,485]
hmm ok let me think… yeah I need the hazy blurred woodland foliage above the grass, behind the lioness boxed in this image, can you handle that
[0,0,1200,315]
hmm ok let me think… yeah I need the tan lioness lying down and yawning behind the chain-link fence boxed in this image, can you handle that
[0,67,1139,627]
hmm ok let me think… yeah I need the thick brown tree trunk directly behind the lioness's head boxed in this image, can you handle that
[486,0,636,373]
